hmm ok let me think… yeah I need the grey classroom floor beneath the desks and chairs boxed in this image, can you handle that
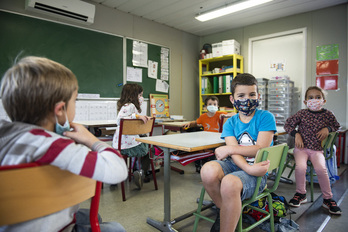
[82,163,348,232]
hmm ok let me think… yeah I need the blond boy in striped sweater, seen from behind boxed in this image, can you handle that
[0,57,127,231]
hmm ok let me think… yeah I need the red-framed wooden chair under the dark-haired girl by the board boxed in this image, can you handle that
[117,118,158,201]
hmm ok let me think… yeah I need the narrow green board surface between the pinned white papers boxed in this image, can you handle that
[126,39,170,98]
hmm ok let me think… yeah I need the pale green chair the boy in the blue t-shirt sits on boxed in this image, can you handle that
[193,144,289,232]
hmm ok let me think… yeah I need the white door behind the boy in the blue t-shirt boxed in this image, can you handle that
[249,29,306,109]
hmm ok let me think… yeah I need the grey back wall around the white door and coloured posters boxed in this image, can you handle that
[200,3,348,127]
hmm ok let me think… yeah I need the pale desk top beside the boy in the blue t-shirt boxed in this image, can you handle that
[136,131,225,152]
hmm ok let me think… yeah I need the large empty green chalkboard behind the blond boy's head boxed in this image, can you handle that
[0,11,123,98]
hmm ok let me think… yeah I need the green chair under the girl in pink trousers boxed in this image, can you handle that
[285,132,338,202]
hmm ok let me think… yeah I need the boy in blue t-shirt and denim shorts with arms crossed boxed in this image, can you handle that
[201,73,276,231]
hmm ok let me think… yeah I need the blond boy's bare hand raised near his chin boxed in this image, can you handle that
[64,122,99,148]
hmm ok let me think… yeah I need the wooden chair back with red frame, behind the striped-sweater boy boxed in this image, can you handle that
[0,163,101,232]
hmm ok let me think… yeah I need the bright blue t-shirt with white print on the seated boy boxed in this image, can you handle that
[221,109,277,162]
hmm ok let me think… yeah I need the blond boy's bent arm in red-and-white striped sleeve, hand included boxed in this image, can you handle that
[43,123,128,184]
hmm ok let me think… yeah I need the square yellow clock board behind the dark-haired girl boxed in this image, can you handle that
[150,94,169,118]
